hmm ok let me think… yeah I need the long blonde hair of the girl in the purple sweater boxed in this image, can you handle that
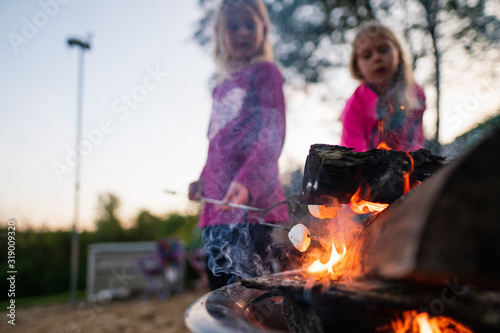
[214,0,273,77]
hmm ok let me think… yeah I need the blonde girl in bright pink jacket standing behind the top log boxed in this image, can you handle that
[341,22,425,151]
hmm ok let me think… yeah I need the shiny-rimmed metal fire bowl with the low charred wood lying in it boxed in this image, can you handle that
[185,271,500,333]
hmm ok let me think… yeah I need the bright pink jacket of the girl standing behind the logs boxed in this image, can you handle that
[341,84,426,151]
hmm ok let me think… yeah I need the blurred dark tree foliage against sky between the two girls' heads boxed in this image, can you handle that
[194,0,376,85]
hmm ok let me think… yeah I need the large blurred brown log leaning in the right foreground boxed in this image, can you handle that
[362,130,500,286]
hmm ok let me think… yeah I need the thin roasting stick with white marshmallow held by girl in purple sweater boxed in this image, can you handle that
[165,190,319,252]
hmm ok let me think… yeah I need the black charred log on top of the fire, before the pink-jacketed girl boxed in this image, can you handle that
[302,144,444,205]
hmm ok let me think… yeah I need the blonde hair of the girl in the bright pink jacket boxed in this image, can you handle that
[349,21,421,111]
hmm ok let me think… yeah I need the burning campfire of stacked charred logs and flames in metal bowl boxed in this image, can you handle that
[186,127,500,333]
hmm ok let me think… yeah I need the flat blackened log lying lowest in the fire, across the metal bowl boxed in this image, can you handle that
[241,272,500,333]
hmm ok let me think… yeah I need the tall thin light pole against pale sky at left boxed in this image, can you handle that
[67,36,90,306]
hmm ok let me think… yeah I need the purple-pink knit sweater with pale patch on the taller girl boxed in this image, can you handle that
[199,62,289,228]
